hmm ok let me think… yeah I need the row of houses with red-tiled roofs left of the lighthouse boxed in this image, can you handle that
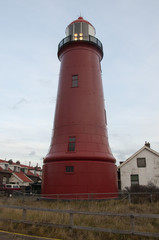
[0,159,42,192]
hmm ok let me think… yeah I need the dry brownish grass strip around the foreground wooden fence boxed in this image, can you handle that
[0,198,159,240]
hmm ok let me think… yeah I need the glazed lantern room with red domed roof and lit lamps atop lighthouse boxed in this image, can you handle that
[66,17,95,40]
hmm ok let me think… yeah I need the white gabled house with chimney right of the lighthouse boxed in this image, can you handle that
[118,142,159,190]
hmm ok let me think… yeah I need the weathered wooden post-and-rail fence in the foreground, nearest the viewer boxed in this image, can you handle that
[0,205,159,238]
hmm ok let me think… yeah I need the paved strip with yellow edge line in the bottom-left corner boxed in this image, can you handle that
[0,230,60,240]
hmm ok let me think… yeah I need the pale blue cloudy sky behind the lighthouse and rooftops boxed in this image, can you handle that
[0,0,159,165]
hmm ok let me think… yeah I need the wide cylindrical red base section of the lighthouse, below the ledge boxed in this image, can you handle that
[42,160,118,199]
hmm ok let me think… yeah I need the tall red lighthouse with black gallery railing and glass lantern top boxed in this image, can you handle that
[42,17,117,199]
